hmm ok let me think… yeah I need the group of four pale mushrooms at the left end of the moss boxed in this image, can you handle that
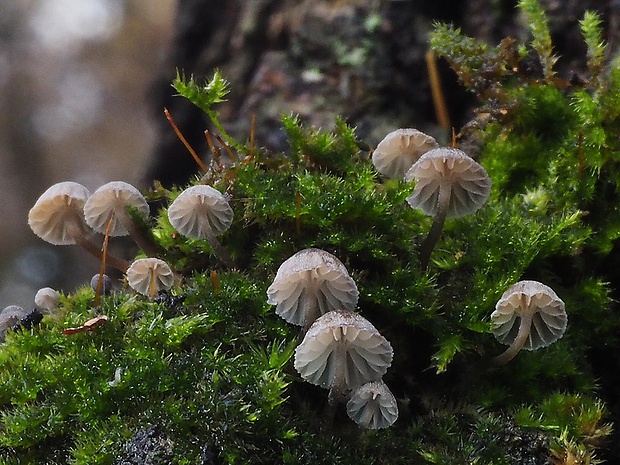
[28,181,233,298]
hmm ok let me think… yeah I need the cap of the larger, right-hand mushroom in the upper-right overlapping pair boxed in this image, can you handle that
[405,147,491,218]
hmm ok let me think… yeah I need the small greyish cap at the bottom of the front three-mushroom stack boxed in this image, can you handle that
[347,380,398,429]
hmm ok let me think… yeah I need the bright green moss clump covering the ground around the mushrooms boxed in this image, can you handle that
[0,0,620,464]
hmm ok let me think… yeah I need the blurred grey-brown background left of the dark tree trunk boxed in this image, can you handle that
[0,0,176,308]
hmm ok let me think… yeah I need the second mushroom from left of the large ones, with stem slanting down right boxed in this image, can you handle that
[84,181,157,254]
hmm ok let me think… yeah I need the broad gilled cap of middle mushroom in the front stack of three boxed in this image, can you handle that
[295,311,394,390]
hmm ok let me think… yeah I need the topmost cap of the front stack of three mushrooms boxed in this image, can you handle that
[267,249,359,326]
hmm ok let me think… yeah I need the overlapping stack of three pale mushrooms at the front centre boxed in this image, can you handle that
[267,249,398,429]
